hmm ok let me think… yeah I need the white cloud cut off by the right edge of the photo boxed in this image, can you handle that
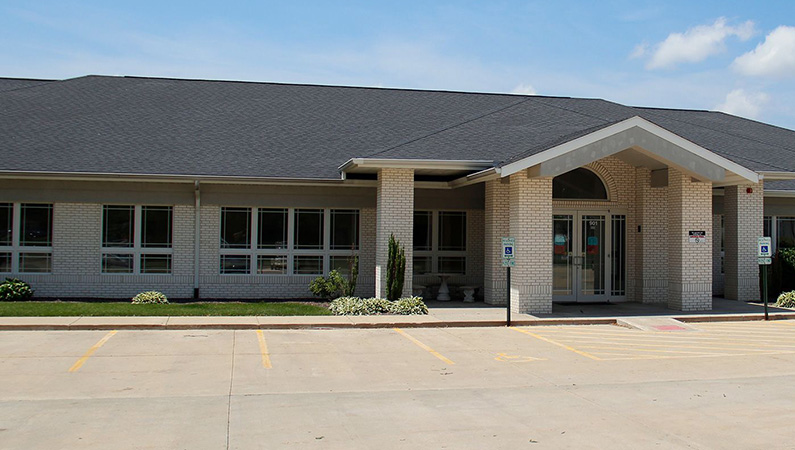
[732,25,795,77]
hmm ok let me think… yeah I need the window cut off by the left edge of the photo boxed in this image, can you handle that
[0,203,52,273]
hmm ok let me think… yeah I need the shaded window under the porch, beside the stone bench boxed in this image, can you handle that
[413,211,467,275]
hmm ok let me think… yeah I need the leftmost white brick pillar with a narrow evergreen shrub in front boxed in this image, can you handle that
[375,169,414,298]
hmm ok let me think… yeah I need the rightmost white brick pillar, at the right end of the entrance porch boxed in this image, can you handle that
[723,183,764,302]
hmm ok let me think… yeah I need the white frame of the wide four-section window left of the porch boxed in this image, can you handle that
[217,206,362,278]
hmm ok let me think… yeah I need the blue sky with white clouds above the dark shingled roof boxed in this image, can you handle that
[0,0,795,129]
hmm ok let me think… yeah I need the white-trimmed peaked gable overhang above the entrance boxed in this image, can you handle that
[500,116,760,184]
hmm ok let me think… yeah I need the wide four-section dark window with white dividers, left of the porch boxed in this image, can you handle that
[220,208,359,275]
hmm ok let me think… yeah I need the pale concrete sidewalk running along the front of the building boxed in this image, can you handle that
[0,298,795,330]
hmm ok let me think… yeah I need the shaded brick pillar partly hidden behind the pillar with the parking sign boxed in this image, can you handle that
[483,179,510,305]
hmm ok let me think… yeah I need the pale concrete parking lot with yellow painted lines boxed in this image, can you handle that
[0,321,795,449]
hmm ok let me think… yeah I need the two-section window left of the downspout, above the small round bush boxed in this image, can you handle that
[101,205,174,275]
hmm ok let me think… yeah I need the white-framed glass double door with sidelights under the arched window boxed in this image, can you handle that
[552,211,626,303]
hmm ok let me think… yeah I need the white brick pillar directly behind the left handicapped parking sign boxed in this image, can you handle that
[508,172,552,314]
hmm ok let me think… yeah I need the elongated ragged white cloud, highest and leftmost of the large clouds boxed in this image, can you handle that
[633,17,754,69]
